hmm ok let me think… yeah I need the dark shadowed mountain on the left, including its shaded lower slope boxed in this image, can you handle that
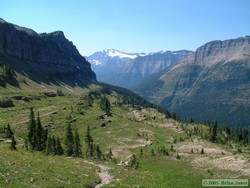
[0,19,96,84]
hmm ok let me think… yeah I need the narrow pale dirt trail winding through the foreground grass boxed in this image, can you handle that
[84,161,113,188]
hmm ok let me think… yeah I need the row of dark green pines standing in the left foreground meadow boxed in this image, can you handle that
[26,108,112,160]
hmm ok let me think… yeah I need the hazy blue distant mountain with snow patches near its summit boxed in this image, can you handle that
[87,50,193,89]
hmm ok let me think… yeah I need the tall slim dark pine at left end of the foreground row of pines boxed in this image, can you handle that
[28,108,36,150]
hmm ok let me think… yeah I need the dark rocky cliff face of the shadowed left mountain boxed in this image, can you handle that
[0,19,96,81]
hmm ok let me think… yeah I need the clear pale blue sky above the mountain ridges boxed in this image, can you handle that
[0,0,250,56]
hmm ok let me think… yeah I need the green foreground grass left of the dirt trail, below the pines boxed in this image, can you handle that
[0,142,100,187]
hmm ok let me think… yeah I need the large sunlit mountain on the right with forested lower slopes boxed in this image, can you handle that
[140,36,250,125]
